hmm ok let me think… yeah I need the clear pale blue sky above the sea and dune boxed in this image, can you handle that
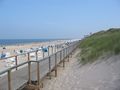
[0,0,120,39]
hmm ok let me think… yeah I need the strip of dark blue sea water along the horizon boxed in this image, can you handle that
[0,39,57,46]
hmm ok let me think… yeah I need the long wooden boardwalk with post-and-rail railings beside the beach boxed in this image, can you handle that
[0,41,79,90]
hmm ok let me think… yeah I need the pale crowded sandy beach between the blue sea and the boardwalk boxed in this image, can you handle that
[0,40,65,71]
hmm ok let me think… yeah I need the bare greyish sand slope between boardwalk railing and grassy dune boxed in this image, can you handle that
[42,51,120,90]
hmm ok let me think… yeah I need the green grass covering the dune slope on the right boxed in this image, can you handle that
[79,28,120,64]
